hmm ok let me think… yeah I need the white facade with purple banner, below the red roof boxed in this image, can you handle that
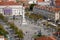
[0,5,24,16]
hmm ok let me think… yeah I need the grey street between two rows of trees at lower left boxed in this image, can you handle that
[0,20,15,40]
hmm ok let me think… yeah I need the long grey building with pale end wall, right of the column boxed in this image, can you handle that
[33,6,60,21]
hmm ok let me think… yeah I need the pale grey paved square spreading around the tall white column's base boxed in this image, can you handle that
[14,20,52,40]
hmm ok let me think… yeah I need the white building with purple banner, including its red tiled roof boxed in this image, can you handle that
[0,1,25,16]
